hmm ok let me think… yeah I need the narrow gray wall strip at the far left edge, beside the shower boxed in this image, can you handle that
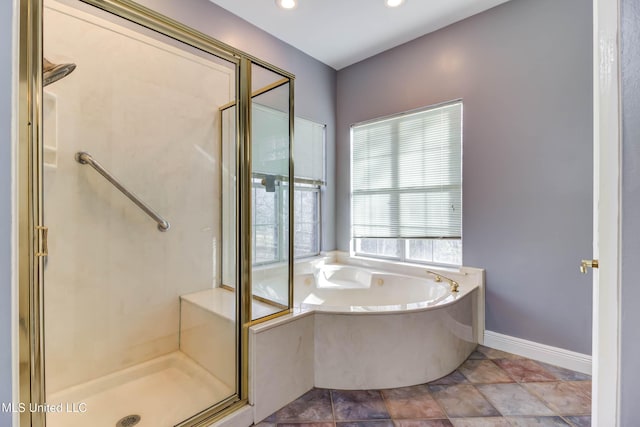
[0,1,13,426]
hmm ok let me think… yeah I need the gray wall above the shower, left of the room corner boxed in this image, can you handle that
[138,0,336,251]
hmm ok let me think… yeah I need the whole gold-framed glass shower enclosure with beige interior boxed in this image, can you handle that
[20,0,293,427]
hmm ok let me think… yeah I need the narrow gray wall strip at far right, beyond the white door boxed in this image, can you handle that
[620,0,640,426]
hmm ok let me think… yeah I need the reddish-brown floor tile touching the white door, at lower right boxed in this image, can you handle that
[523,381,591,415]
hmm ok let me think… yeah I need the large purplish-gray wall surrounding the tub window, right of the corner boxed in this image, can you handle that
[336,0,593,354]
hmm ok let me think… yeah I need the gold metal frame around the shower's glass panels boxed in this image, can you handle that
[17,0,294,427]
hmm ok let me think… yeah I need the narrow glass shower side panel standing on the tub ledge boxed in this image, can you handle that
[251,65,291,319]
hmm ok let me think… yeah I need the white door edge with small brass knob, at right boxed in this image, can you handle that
[592,0,621,427]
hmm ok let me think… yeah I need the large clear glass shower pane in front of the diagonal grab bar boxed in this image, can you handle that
[44,0,238,427]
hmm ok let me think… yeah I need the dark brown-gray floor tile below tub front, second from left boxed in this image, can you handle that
[331,390,391,421]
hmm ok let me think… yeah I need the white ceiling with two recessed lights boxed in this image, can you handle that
[210,0,508,70]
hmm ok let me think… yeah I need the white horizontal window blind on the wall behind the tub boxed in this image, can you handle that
[351,101,462,238]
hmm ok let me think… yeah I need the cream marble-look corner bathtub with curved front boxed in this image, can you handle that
[294,264,478,389]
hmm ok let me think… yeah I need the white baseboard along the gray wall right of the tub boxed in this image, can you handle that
[484,331,591,375]
